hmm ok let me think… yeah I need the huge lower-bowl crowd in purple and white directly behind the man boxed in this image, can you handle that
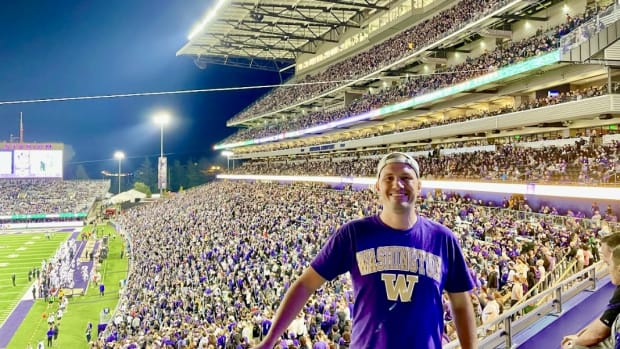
[91,181,612,349]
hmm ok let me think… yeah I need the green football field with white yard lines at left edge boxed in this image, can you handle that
[0,231,71,325]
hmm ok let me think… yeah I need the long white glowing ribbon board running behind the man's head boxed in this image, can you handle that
[216,175,620,200]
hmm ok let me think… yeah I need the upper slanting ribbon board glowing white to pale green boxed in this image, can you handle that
[213,50,560,150]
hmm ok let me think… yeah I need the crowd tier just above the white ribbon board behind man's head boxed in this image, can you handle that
[233,139,620,188]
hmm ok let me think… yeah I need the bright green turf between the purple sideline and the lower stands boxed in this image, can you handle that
[7,226,127,349]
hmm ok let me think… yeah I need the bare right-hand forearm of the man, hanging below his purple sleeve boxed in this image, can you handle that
[448,292,478,349]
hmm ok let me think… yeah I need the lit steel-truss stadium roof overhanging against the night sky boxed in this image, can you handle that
[177,0,396,68]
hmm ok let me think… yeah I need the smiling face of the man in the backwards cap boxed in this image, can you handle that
[375,163,420,213]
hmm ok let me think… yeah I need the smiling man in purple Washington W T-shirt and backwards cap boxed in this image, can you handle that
[257,153,478,349]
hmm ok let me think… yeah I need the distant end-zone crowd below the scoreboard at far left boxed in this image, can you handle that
[0,179,110,216]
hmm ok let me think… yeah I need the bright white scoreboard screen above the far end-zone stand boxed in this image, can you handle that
[0,143,64,178]
